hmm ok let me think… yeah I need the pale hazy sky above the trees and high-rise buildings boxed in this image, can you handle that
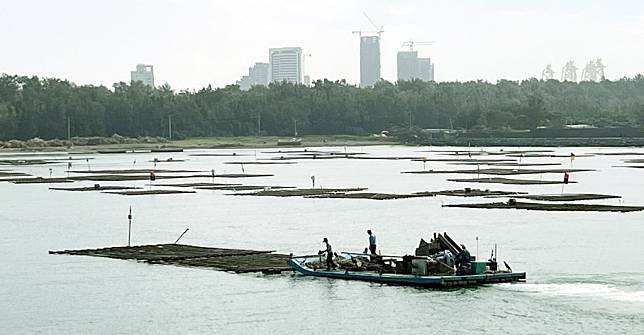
[0,0,644,89]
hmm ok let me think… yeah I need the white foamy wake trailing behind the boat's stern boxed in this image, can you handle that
[500,283,644,303]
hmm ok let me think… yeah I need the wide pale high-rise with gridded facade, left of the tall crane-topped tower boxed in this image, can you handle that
[268,48,302,84]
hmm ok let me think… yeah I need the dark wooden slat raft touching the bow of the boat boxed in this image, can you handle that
[49,244,292,273]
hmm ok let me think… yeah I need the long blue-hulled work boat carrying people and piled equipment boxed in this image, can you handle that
[288,233,526,288]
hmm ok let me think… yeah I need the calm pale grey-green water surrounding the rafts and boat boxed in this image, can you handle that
[0,146,644,334]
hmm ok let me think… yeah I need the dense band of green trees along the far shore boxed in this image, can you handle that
[0,74,644,140]
